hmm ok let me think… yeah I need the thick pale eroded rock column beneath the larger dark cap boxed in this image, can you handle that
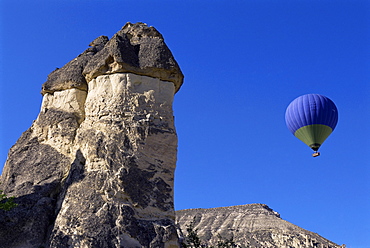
[52,73,178,247]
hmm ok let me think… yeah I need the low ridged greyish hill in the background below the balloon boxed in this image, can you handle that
[176,204,342,248]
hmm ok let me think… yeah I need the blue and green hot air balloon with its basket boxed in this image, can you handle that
[285,94,338,157]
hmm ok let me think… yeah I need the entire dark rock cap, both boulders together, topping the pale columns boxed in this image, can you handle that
[41,22,184,95]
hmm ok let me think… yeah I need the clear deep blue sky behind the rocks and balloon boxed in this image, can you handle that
[0,0,370,248]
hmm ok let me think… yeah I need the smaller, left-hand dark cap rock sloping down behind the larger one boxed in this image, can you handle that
[41,36,108,95]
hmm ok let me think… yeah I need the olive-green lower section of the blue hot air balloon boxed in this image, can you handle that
[294,124,333,148]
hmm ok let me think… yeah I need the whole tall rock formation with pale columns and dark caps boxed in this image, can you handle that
[0,23,183,248]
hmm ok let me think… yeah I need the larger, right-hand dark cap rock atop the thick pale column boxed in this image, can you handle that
[83,23,184,92]
